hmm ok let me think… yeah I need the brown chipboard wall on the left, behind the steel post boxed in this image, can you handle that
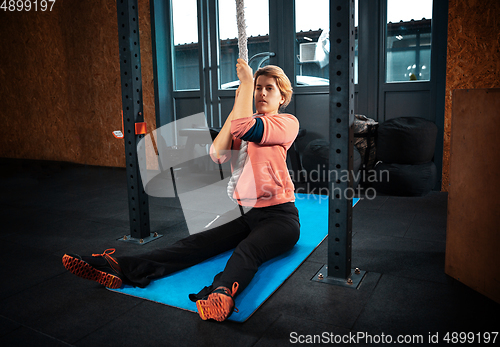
[0,0,155,166]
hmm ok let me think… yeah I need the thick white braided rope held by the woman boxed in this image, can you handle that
[227,0,248,202]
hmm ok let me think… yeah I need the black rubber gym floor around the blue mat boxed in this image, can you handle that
[0,159,500,346]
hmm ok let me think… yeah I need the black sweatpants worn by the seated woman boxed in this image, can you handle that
[117,202,300,301]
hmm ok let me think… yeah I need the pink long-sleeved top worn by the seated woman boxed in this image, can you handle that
[210,114,299,207]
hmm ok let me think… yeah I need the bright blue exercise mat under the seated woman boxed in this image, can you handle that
[113,194,359,322]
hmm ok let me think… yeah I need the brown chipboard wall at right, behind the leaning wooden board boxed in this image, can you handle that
[444,0,500,191]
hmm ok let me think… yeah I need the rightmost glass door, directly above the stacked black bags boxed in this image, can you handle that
[378,0,435,121]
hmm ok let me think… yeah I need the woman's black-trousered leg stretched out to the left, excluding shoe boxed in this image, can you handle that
[116,209,250,287]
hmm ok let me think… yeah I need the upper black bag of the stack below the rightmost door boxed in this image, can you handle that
[377,117,437,164]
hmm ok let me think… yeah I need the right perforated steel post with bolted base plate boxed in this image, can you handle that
[314,0,365,288]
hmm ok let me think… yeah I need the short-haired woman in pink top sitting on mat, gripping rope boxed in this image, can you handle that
[63,59,300,321]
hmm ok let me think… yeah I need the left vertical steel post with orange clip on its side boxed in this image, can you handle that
[116,0,150,243]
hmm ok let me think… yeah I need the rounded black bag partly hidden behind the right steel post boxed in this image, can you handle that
[302,139,363,188]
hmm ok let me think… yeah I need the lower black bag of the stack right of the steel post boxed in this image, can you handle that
[372,162,436,196]
